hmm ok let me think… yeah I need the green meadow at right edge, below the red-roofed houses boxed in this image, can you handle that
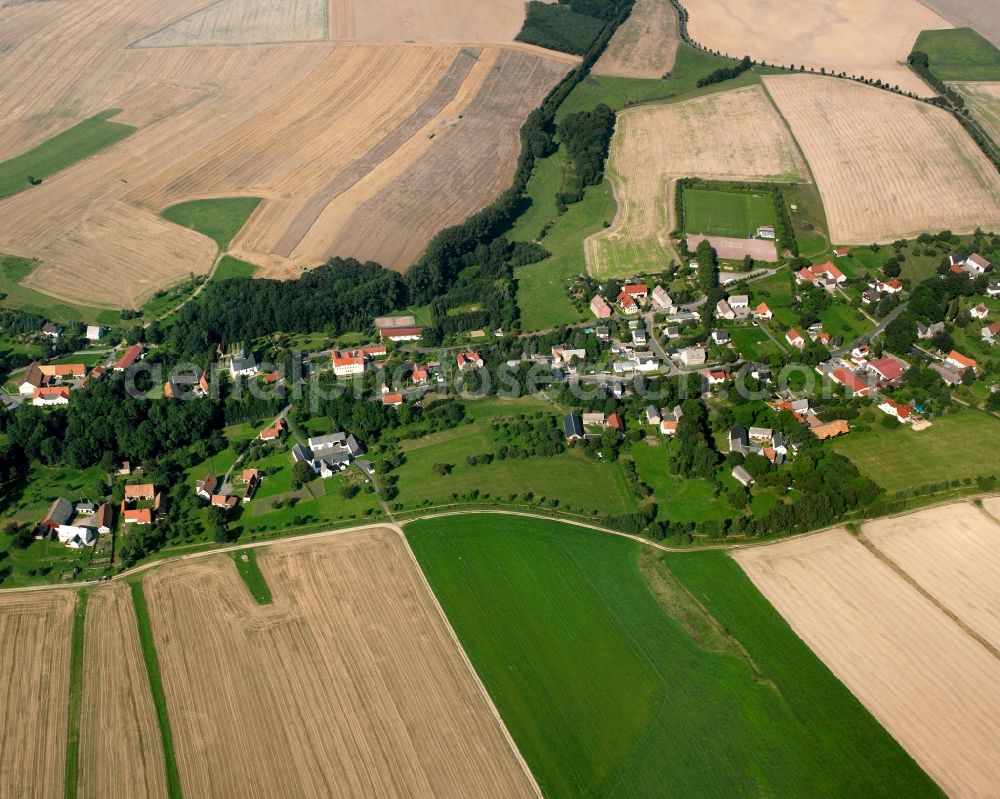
[831,411,1000,491]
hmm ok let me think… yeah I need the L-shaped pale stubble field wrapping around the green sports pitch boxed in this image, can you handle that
[585,86,806,277]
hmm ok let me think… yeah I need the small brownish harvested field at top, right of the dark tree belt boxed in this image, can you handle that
[591,0,680,78]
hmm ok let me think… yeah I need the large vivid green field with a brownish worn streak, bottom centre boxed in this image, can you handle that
[406,516,941,799]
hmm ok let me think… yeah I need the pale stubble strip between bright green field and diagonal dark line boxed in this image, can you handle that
[734,517,1000,797]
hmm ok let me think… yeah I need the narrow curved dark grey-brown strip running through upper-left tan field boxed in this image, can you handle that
[275,48,482,258]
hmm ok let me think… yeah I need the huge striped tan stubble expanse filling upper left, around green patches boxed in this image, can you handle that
[0,0,577,308]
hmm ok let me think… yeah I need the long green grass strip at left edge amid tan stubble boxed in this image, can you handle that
[0,108,136,197]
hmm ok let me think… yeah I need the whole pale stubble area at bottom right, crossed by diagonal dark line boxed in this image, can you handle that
[733,504,1000,797]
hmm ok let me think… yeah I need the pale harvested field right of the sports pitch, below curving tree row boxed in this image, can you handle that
[764,75,1000,244]
